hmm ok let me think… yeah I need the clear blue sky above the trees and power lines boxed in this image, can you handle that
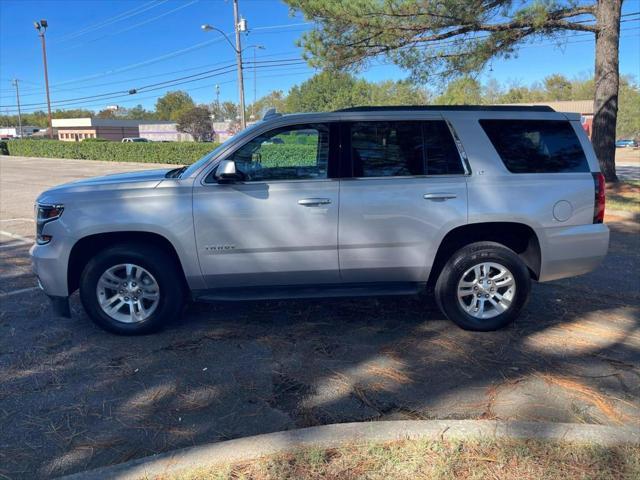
[0,0,640,114]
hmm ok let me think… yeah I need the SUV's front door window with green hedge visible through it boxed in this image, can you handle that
[229,124,329,182]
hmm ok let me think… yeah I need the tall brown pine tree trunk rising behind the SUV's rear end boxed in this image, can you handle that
[591,0,622,182]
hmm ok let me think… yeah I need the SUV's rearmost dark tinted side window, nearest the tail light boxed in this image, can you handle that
[480,120,589,173]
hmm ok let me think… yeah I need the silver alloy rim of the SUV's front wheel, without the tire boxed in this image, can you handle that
[96,263,160,323]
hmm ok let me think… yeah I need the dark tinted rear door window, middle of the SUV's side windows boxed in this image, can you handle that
[350,121,464,177]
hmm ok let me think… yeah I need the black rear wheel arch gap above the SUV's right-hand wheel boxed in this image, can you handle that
[428,222,542,287]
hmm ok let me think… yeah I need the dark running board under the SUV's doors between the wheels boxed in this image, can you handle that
[192,282,426,302]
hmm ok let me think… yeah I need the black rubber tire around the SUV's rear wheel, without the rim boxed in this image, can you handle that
[435,242,531,332]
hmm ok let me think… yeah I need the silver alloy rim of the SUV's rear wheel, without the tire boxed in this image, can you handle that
[458,262,516,320]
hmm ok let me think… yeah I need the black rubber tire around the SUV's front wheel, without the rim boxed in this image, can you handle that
[80,243,185,335]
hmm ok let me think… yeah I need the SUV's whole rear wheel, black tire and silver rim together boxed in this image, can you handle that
[435,242,531,331]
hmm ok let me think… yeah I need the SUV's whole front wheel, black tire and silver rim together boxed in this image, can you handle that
[80,244,184,335]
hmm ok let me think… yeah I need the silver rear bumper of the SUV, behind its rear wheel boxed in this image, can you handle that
[539,223,609,282]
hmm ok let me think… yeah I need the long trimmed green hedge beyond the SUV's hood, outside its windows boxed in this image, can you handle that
[0,140,218,165]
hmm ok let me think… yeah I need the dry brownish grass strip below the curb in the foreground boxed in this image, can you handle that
[159,440,640,480]
